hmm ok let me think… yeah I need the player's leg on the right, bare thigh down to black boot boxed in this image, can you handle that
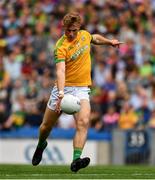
[71,99,90,172]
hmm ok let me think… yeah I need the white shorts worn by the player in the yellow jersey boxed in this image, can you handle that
[47,86,90,110]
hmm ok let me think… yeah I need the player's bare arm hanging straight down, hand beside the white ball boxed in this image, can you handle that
[55,62,65,113]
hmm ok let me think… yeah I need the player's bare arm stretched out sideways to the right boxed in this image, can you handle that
[91,34,123,47]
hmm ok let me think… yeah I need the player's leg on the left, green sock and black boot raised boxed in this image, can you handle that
[32,107,60,166]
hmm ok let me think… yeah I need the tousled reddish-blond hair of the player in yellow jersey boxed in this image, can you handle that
[63,12,81,27]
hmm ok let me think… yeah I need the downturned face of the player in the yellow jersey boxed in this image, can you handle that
[65,25,80,41]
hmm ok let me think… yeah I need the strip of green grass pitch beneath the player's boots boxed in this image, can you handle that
[0,164,155,179]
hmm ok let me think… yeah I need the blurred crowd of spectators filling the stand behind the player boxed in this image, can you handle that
[0,0,155,131]
